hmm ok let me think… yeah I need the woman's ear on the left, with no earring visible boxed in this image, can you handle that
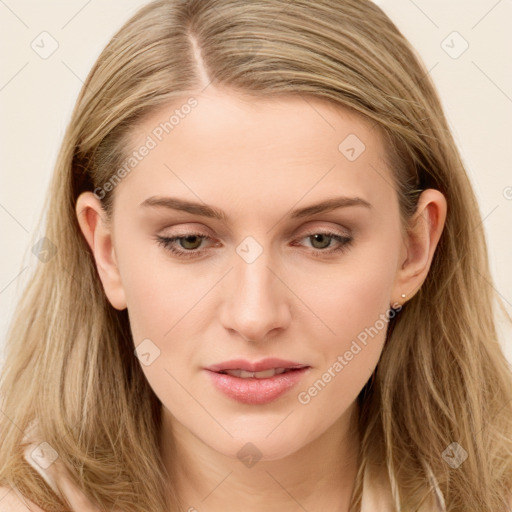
[75,192,126,310]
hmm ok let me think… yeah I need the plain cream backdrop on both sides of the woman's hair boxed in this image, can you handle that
[0,0,512,364]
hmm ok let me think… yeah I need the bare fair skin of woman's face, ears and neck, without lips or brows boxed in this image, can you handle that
[76,86,446,512]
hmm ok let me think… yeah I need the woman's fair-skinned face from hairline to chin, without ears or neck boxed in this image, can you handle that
[85,87,412,460]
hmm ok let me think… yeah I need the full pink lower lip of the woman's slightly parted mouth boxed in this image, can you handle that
[207,367,309,405]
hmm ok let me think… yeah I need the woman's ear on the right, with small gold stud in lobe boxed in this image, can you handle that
[392,189,447,304]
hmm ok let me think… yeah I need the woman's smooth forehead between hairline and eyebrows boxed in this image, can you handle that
[119,86,394,216]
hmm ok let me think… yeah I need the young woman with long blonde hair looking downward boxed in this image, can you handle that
[0,0,512,512]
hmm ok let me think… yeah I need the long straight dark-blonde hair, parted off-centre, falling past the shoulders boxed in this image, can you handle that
[0,0,512,512]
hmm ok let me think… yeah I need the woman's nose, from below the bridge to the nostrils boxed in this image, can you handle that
[220,246,293,342]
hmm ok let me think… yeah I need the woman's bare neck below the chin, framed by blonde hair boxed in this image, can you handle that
[162,403,359,512]
